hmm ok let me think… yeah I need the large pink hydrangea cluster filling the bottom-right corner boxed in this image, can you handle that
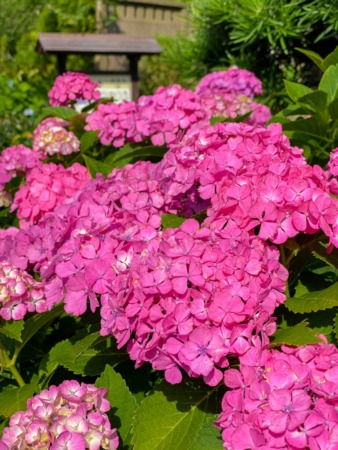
[218,337,338,450]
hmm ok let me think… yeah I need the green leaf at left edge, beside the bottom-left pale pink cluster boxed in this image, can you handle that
[0,384,36,417]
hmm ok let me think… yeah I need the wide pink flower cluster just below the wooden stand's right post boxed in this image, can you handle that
[85,85,209,147]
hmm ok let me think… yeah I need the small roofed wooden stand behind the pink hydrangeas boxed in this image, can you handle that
[37,33,161,100]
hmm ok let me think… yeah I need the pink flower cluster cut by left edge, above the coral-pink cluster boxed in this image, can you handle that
[0,144,45,207]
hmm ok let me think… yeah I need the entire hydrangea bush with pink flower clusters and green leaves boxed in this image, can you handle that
[0,60,338,450]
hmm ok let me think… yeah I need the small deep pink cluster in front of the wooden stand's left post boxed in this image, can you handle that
[48,72,101,106]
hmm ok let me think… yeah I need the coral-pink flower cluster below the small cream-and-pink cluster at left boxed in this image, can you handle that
[11,163,90,228]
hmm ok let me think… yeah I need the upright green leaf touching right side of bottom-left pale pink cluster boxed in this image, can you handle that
[95,365,137,445]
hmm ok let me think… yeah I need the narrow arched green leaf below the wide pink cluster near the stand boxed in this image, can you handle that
[105,144,168,167]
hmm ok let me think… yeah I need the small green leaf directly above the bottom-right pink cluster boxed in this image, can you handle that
[271,321,322,346]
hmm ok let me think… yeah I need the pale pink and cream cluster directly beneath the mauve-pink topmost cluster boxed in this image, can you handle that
[200,93,272,126]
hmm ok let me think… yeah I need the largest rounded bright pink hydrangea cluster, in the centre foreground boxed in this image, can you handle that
[101,219,288,386]
